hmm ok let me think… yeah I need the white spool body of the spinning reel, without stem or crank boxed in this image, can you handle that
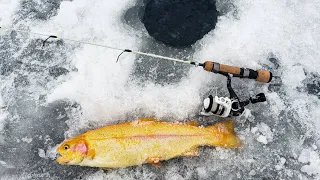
[200,95,233,117]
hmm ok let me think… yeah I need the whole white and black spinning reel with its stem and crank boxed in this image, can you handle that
[200,73,266,117]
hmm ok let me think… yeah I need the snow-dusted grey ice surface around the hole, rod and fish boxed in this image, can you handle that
[0,0,320,179]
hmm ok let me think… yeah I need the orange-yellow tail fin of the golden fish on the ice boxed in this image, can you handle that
[207,120,242,148]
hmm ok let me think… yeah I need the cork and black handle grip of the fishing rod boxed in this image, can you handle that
[200,61,272,83]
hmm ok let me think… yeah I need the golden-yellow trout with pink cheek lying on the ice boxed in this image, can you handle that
[56,118,242,169]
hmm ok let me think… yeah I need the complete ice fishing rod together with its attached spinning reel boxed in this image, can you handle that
[0,26,277,117]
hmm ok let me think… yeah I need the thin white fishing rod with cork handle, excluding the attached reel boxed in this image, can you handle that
[0,26,273,83]
